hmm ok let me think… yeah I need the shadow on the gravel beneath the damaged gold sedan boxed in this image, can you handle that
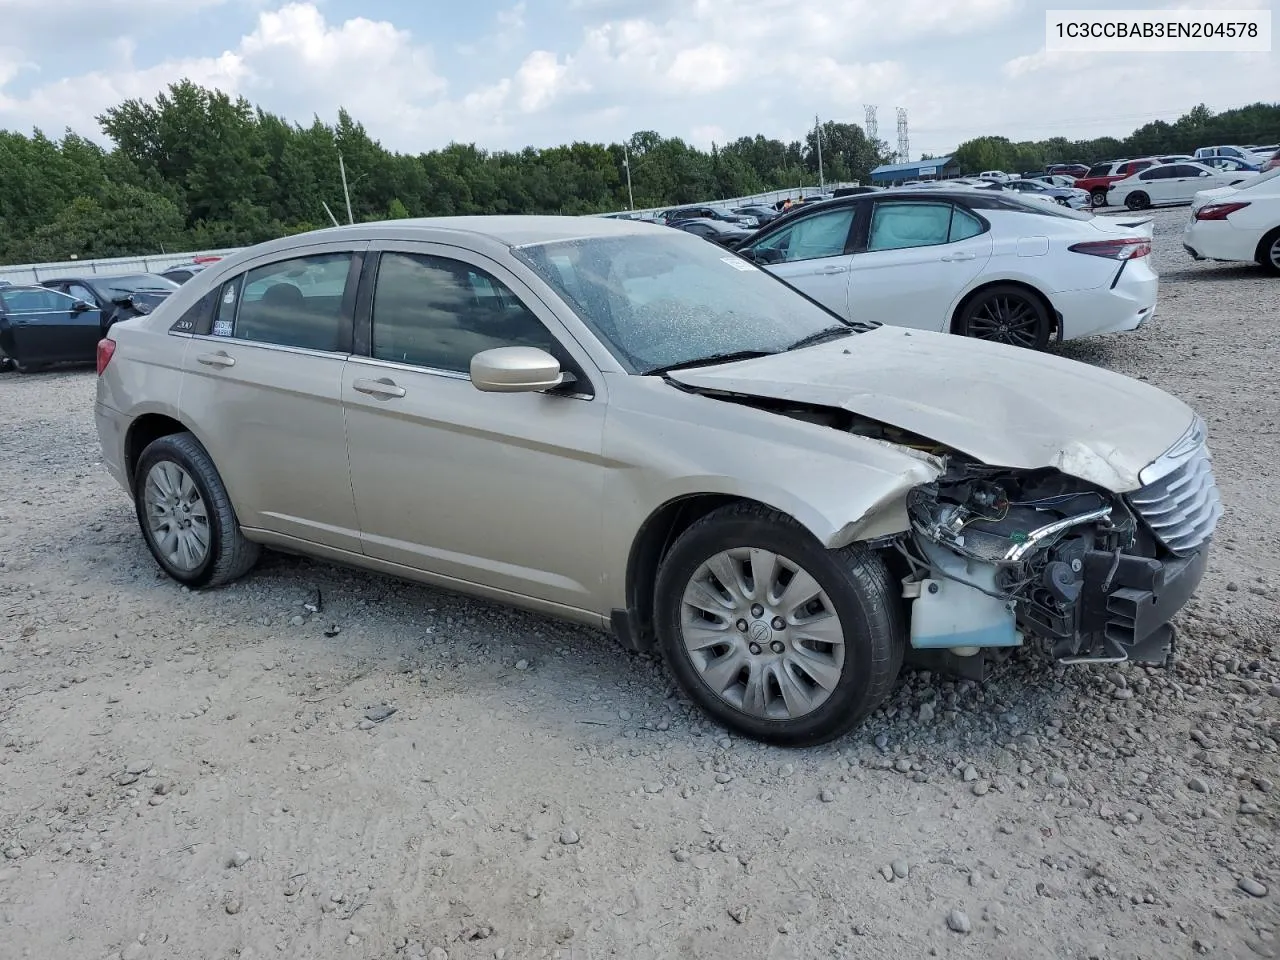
[37,491,1101,764]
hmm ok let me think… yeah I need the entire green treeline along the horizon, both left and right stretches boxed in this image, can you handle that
[0,82,1280,264]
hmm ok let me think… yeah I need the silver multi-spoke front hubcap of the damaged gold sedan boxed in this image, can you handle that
[681,547,845,721]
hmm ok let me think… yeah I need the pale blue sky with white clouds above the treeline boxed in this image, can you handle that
[0,0,1280,156]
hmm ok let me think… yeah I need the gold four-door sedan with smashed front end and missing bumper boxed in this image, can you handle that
[97,218,1221,745]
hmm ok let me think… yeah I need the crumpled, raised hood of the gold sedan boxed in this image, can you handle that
[668,326,1194,493]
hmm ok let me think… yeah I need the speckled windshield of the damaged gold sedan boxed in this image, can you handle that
[515,233,851,374]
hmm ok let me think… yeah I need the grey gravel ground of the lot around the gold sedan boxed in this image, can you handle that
[0,204,1280,960]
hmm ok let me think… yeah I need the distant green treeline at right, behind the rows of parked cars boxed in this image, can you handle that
[954,102,1280,173]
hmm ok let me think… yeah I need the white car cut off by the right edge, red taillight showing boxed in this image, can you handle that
[1183,168,1280,274]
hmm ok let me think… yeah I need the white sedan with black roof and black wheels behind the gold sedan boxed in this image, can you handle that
[739,187,1158,349]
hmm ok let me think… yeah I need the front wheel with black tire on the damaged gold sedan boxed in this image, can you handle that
[654,503,906,746]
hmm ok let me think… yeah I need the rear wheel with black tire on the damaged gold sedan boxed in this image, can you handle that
[133,433,261,588]
